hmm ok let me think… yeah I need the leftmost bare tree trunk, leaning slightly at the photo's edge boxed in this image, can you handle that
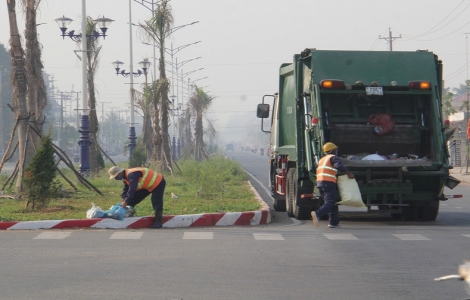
[7,0,29,193]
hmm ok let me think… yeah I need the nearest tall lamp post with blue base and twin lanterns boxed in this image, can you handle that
[55,0,114,175]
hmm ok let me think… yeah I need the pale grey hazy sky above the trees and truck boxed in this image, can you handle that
[0,0,470,141]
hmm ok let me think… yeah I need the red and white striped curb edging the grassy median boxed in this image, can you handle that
[0,182,272,230]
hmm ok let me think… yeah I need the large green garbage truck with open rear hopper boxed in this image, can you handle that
[257,48,461,221]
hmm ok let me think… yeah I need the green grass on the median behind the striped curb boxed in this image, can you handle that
[0,156,260,222]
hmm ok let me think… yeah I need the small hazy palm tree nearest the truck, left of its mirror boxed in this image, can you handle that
[189,86,214,161]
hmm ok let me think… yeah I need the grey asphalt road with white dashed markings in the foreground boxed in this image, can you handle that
[0,151,470,300]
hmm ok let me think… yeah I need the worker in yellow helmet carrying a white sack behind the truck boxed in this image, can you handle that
[312,142,354,228]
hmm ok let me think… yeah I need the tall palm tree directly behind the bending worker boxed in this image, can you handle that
[140,0,173,170]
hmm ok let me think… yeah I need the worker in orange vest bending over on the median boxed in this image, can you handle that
[108,166,166,228]
